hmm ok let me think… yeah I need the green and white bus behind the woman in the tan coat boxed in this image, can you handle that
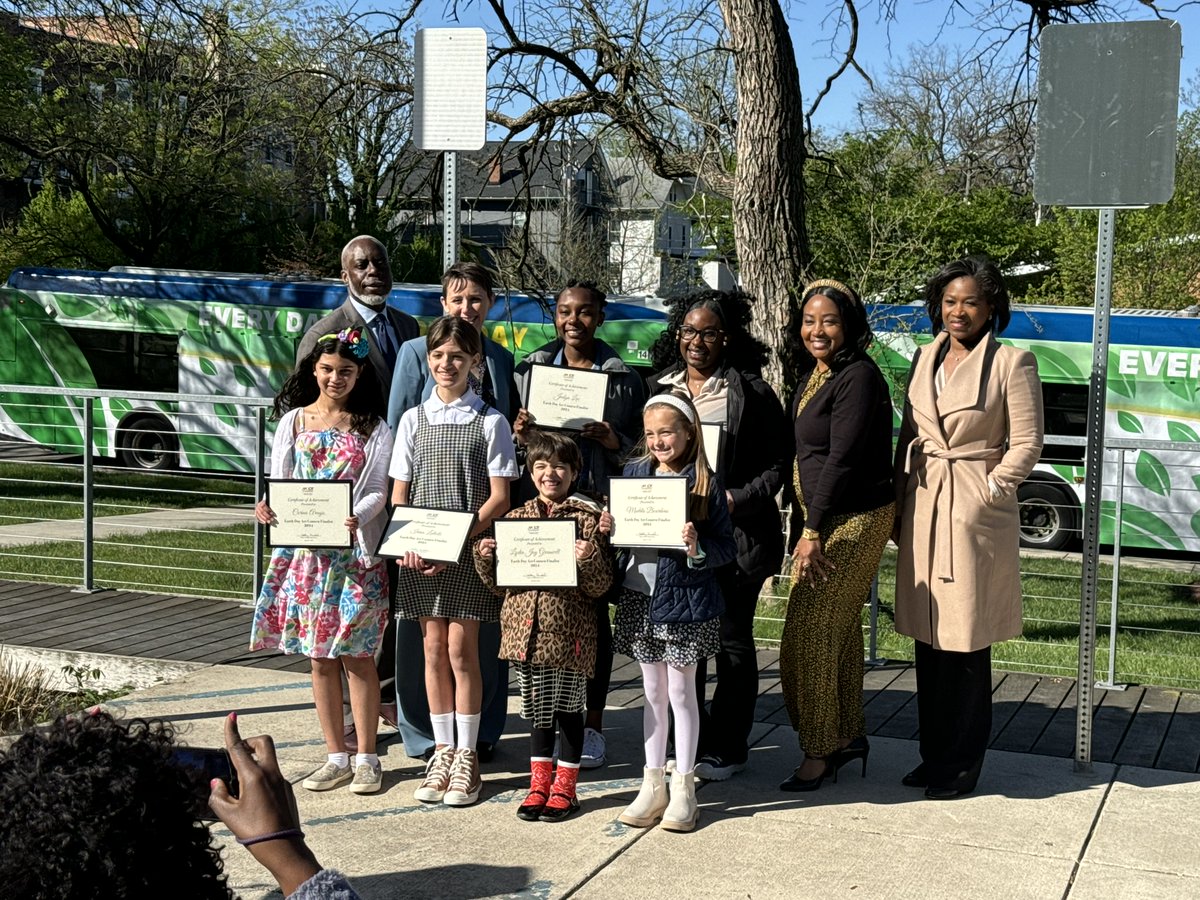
[871,305,1200,553]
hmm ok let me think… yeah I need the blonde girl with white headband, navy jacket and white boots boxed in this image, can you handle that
[601,394,737,832]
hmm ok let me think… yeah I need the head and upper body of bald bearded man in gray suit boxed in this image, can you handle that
[296,234,421,381]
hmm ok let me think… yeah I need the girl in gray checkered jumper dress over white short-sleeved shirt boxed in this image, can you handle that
[390,316,517,806]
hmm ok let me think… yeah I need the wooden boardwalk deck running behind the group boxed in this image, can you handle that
[0,581,1200,772]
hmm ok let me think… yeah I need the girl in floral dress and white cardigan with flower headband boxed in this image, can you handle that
[250,329,391,793]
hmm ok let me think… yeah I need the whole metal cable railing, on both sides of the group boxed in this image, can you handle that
[0,385,1200,688]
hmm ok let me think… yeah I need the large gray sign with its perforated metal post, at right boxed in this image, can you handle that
[1033,20,1183,772]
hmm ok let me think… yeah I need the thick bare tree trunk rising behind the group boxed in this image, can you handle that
[721,0,811,390]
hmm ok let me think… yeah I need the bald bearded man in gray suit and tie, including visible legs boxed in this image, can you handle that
[296,234,421,752]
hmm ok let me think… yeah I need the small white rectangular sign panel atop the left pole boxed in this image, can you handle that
[413,28,487,150]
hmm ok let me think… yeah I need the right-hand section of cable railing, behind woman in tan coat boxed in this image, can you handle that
[755,437,1200,688]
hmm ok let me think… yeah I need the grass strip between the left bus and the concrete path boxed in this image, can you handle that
[0,461,254,524]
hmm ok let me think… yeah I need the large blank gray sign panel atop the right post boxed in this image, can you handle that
[1033,20,1183,206]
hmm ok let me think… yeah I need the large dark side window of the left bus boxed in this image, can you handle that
[68,328,179,394]
